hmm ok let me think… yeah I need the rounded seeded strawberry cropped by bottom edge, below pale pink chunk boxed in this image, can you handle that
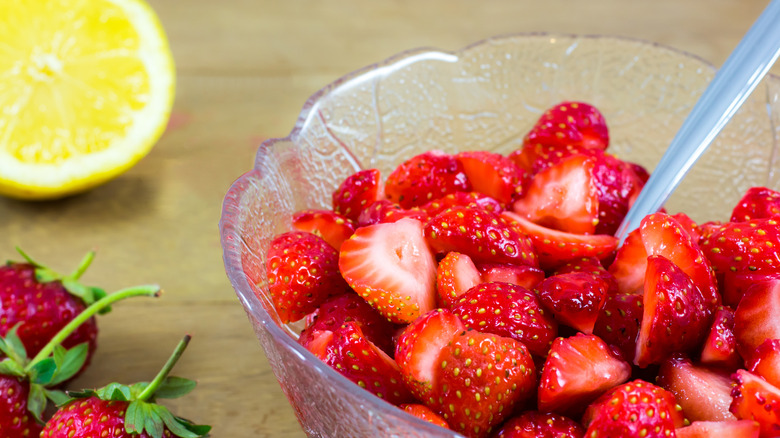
[583,380,683,438]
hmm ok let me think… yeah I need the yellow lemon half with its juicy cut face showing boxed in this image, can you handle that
[0,0,175,199]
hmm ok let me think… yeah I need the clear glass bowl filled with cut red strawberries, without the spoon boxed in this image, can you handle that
[220,34,780,438]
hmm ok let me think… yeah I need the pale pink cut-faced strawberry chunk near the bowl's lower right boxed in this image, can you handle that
[656,356,736,421]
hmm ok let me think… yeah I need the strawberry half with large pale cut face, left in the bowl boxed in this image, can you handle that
[338,218,436,323]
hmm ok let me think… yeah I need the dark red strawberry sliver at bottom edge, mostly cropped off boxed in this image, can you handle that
[495,411,585,438]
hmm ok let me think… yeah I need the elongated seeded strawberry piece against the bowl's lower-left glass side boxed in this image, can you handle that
[310,321,413,404]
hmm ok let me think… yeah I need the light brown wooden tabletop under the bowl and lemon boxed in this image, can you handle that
[0,0,778,437]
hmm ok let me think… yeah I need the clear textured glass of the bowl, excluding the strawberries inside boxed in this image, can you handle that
[220,34,780,437]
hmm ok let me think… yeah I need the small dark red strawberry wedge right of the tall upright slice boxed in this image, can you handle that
[699,306,742,371]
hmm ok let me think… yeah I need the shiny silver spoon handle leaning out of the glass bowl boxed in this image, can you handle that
[616,0,780,243]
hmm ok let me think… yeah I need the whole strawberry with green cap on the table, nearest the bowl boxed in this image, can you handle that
[41,336,211,438]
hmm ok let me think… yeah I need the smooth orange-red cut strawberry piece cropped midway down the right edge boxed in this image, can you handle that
[734,280,780,359]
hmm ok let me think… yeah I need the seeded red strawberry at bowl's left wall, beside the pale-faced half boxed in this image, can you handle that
[266,231,347,323]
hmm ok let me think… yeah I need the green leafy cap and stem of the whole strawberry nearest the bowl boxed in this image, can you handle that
[68,335,211,438]
